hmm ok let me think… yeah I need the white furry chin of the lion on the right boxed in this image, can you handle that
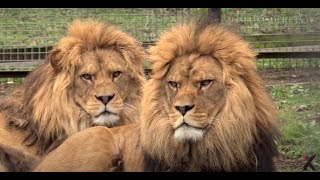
[174,125,205,142]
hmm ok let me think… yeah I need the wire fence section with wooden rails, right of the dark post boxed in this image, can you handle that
[221,8,320,69]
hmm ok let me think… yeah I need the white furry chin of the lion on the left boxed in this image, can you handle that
[92,113,120,127]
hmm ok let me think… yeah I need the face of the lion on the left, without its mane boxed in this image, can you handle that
[74,50,132,126]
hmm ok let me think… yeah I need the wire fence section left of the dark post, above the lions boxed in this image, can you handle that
[0,8,202,69]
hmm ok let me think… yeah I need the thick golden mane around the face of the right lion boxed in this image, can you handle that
[141,22,279,171]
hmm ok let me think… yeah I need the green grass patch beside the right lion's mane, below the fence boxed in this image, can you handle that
[269,83,320,158]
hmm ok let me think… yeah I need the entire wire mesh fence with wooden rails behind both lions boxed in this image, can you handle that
[0,8,320,83]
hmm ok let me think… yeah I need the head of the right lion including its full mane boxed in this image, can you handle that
[140,22,278,171]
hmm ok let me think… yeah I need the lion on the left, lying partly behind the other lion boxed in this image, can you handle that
[0,19,146,171]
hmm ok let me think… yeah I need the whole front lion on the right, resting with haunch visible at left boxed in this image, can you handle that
[34,22,279,172]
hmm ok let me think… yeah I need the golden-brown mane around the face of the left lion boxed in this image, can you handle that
[0,20,144,154]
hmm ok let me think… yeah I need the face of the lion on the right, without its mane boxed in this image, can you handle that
[164,55,226,141]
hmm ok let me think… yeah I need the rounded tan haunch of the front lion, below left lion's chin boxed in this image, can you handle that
[34,126,122,172]
